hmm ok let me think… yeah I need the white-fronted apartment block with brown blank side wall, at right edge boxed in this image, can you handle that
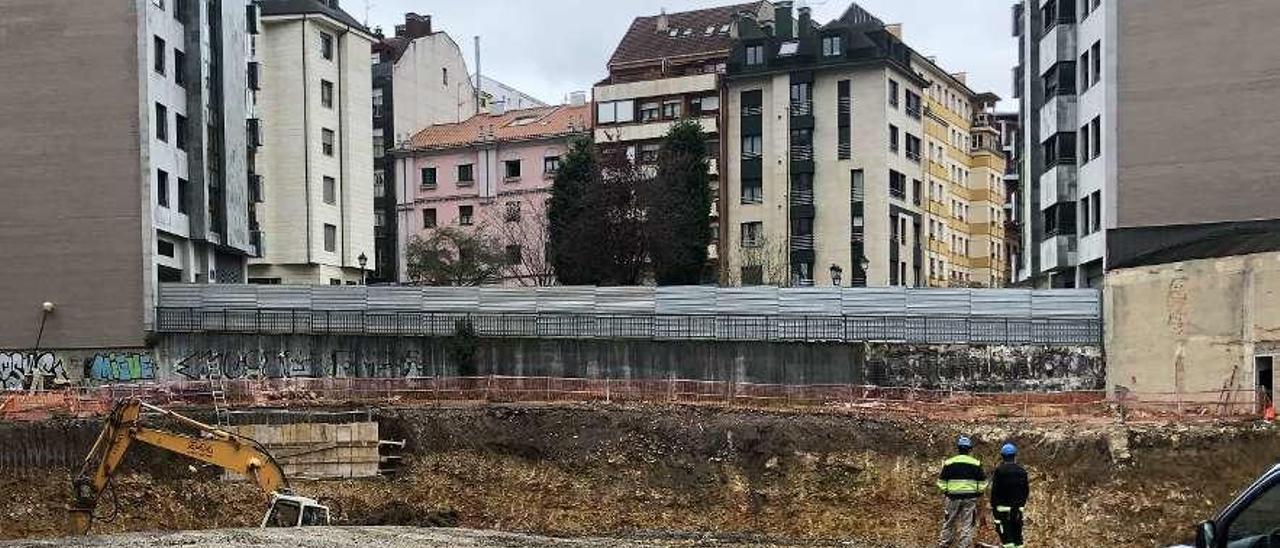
[1012,0,1280,287]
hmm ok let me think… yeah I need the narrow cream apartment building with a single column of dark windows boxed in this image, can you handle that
[250,0,376,284]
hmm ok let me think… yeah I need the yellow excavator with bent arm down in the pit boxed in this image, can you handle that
[68,398,329,535]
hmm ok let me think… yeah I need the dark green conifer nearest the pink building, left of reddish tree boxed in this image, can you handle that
[547,137,603,286]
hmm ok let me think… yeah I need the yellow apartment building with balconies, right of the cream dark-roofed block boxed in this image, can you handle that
[913,55,1009,287]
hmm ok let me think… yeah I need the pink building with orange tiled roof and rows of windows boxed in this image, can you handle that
[396,105,591,286]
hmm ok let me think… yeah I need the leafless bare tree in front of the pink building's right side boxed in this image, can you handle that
[481,198,556,287]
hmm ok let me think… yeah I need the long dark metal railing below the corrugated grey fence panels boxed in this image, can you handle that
[156,306,1102,346]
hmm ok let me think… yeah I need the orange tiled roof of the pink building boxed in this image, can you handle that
[410,104,591,150]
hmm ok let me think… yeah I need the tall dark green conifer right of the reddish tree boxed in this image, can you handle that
[645,120,712,286]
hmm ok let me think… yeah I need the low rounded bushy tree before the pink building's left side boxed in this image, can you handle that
[404,227,507,286]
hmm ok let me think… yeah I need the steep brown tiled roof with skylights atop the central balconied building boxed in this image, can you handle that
[609,1,763,67]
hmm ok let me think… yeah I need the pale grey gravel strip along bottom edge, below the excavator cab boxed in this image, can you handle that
[0,528,887,548]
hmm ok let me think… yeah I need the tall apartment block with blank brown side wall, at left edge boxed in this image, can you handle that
[0,0,259,348]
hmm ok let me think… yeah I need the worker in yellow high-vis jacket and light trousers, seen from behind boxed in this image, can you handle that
[938,435,987,548]
